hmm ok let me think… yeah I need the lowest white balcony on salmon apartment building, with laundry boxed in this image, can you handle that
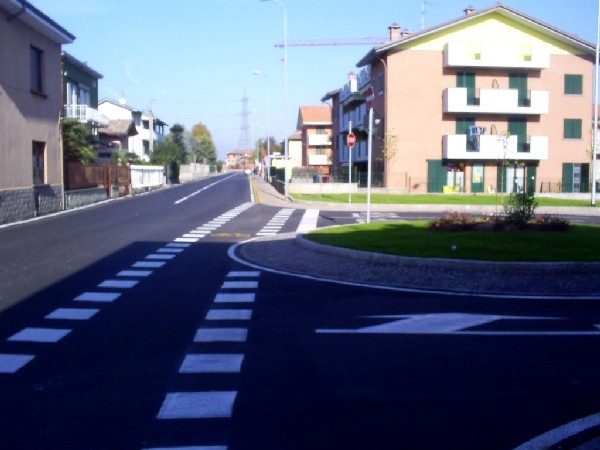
[442,134,548,161]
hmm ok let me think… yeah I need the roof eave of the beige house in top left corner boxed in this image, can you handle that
[0,0,75,44]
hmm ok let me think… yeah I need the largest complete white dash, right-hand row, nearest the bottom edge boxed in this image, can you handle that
[157,391,237,419]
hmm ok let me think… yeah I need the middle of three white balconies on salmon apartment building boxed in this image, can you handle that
[443,88,550,115]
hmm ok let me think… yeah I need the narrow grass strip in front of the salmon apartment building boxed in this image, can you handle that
[294,194,590,211]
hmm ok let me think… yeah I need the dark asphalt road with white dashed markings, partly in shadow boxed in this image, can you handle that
[0,175,600,450]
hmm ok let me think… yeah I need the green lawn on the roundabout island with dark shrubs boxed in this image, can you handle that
[305,221,600,262]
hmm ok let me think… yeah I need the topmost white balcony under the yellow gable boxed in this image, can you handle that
[444,42,550,70]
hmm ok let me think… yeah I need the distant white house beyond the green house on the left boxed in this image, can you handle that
[98,98,167,161]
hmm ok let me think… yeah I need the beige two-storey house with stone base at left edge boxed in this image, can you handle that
[0,0,75,223]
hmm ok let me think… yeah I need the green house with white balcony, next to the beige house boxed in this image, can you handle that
[62,52,109,135]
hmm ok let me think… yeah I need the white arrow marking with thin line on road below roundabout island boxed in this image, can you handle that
[316,313,600,336]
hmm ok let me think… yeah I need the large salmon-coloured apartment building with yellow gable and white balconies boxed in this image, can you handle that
[338,3,595,193]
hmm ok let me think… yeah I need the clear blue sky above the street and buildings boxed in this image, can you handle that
[31,0,598,158]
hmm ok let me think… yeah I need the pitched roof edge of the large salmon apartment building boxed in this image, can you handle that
[356,3,596,67]
